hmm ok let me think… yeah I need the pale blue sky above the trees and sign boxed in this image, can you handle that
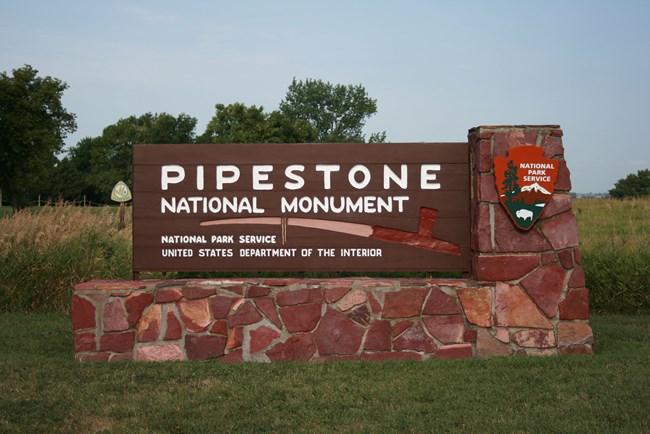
[0,0,650,193]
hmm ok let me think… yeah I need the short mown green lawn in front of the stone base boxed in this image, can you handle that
[0,314,650,433]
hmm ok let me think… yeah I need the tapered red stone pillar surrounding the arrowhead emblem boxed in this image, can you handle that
[469,125,593,353]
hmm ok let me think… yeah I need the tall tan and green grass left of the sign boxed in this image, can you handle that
[0,204,131,312]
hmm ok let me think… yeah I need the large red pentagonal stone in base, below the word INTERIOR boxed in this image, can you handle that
[314,308,364,356]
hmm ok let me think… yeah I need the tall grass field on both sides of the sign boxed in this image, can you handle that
[0,199,650,313]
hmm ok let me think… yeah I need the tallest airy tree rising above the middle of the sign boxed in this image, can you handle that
[280,78,385,142]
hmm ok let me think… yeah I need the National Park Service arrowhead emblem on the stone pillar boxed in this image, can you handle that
[494,146,559,230]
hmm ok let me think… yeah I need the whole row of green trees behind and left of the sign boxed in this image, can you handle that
[0,65,386,209]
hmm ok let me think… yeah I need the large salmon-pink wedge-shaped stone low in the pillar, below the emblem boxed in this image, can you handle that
[494,282,553,329]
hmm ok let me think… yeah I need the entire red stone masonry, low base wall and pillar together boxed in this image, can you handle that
[72,125,593,362]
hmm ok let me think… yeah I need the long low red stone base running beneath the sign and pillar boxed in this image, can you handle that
[72,277,593,362]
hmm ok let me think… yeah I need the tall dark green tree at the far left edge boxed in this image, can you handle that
[0,65,77,209]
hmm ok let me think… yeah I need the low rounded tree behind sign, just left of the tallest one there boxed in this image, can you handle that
[196,103,316,143]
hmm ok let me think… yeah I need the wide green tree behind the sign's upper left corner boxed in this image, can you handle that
[61,113,197,203]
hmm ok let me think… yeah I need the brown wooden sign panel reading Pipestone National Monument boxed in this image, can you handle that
[133,143,470,272]
